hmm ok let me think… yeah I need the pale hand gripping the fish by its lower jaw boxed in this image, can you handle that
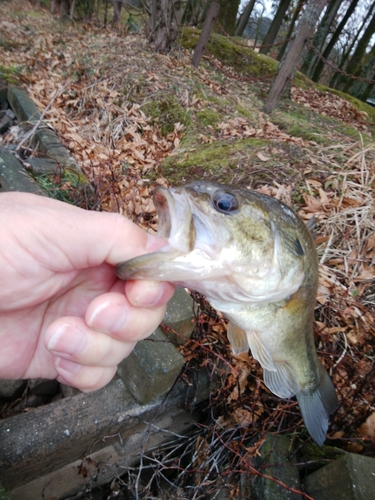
[0,193,174,391]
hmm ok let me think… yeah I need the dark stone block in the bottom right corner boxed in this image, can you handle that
[305,453,375,500]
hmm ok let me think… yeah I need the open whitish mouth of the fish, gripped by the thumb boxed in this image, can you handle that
[116,186,196,281]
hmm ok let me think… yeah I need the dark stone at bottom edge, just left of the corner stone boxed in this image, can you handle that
[254,434,302,500]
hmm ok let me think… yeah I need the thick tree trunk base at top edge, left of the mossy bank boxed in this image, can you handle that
[148,0,178,54]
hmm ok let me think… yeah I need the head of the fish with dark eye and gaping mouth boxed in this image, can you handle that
[116,181,303,302]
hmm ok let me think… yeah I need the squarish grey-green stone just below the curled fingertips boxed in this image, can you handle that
[117,328,184,404]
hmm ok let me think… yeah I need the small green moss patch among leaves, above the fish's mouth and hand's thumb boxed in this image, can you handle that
[143,95,191,136]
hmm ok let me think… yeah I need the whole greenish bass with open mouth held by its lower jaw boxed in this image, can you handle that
[116,180,338,446]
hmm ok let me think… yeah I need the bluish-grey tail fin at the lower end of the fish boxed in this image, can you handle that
[296,366,339,446]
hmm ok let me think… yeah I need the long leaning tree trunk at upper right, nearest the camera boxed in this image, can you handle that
[263,0,328,113]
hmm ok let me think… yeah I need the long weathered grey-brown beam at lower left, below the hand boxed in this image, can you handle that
[0,376,208,492]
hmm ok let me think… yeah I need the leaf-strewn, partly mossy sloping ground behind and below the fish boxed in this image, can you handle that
[0,1,375,496]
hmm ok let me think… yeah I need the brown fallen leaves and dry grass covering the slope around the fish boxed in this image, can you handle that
[0,2,375,476]
